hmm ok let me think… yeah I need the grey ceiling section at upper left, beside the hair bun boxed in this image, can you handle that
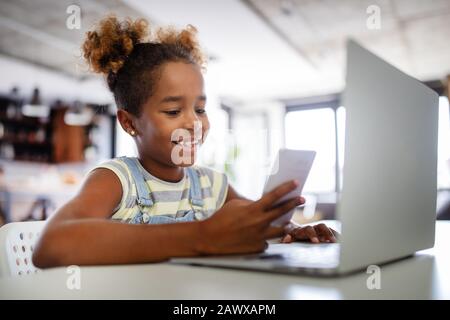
[0,0,139,79]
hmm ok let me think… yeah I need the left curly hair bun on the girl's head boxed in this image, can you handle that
[82,15,148,75]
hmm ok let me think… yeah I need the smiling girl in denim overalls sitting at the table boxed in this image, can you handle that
[33,16,336,268]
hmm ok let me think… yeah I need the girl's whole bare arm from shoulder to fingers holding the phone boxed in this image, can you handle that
[33,169,300,268]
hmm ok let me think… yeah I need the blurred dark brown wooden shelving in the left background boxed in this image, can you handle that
[0,92,114,163]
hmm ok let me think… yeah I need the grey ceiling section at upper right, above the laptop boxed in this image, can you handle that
[245,0,450,94]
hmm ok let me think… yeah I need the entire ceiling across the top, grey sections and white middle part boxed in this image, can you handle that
[0,0,450,100]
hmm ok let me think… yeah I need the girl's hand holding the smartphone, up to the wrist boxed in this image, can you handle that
[200,181,304,254]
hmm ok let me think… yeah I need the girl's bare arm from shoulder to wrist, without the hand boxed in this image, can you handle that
[33,169,206,268]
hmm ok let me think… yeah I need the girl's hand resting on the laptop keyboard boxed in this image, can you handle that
[281,223,339,243]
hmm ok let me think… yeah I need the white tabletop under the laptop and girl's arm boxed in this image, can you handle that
[0,222,450,300]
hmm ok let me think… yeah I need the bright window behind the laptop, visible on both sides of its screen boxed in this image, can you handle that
[285,96,450,193]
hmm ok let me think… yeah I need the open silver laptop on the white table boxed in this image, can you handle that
[171,40,439,275]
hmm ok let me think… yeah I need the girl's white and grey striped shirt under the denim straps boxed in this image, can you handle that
[94,158,228,222]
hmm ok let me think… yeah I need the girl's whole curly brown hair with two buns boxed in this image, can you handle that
[82,15,206,116]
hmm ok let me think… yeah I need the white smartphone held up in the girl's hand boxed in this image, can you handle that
[263,149,316,226]
